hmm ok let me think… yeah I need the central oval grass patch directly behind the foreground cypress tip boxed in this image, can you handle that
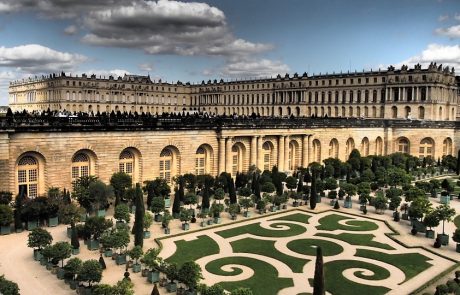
[287,239,343,257]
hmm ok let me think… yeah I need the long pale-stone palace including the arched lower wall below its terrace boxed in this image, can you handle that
[0,64,460,197]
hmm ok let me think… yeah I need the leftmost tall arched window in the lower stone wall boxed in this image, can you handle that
[18,156,38,198]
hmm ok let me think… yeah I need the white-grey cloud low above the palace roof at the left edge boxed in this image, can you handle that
[0,44,88,73]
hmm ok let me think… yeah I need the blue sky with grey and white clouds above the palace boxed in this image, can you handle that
[0,0,460,105]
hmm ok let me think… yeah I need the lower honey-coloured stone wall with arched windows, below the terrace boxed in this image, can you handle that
[0,118,459,195]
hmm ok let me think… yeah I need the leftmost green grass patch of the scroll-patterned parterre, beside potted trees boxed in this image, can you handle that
[166,236,219,266]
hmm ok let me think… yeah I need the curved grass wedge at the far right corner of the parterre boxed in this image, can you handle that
[356,249,432,282]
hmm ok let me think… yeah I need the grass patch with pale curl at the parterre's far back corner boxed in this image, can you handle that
[316,214,379,231]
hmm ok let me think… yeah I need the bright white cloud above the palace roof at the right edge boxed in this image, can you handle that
[396,44,460,73]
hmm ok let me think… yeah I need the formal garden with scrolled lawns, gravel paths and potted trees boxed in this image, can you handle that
[0,150,460,295]
